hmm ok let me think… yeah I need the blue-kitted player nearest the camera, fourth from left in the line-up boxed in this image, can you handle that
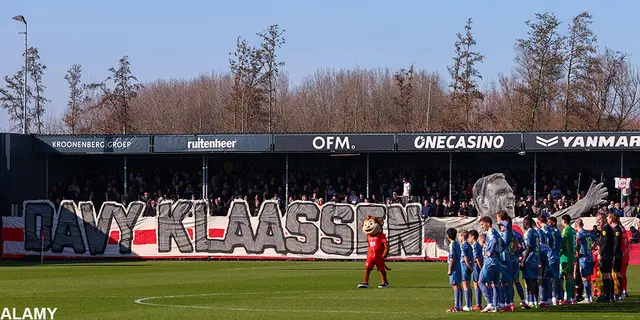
[479,216,503,312]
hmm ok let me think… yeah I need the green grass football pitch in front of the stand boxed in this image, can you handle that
[0,261,640,320]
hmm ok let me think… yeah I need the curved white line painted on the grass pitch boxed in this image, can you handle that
[134,290,421,314]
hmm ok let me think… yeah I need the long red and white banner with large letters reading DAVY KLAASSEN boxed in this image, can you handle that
[2,200,638,260]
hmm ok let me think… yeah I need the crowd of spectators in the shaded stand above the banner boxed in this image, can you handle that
[49,154,640,217]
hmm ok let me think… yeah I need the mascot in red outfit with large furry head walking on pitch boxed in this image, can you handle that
[358,216,391,288]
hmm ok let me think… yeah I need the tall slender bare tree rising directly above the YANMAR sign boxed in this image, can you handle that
[563,12,597,130]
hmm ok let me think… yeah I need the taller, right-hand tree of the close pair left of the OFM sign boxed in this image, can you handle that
[257,24,286,132]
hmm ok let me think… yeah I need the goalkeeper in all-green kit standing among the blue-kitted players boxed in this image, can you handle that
[560,215,576,304]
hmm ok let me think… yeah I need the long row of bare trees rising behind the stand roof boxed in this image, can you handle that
[46,13,640,134]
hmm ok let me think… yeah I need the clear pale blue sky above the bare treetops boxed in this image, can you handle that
[0,0,640,131]
